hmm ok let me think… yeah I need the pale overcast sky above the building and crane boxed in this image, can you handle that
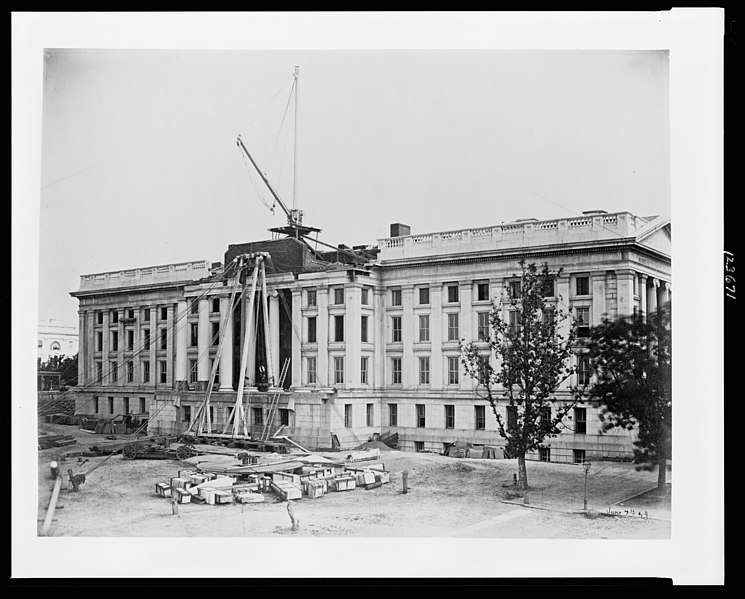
[39,49,670,324]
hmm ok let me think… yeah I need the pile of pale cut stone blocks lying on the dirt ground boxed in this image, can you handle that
[155,456,390,505]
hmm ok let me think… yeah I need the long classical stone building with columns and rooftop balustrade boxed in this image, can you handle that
[72,211,671,462]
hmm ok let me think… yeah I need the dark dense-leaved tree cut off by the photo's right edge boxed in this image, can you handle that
[589,306,673,489]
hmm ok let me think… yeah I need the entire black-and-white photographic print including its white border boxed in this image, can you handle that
[12,9,720,584]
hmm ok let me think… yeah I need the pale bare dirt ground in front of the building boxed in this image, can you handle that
[38,425,671,539]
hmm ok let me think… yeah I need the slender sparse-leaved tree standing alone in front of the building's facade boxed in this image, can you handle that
[461,260,582,490]
